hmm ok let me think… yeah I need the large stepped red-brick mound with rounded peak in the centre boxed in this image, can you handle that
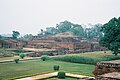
[27,32,105,52]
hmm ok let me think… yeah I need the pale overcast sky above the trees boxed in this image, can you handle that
[0,0,120,34]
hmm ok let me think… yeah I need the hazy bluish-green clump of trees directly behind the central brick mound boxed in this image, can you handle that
[38,21,103,38]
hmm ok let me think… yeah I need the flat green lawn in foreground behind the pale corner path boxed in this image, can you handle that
[0,60,94,78]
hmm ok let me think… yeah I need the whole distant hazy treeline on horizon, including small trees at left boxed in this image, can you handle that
[0,20,103,40]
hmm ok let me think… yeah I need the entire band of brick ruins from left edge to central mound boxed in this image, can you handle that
[0,32,105,56]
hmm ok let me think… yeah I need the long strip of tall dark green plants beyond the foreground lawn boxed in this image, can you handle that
[52,55,120,64]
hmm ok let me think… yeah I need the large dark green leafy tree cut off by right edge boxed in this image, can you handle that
[100,17,120,55]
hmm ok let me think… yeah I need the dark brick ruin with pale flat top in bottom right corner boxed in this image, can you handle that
[93,60,120,80]
